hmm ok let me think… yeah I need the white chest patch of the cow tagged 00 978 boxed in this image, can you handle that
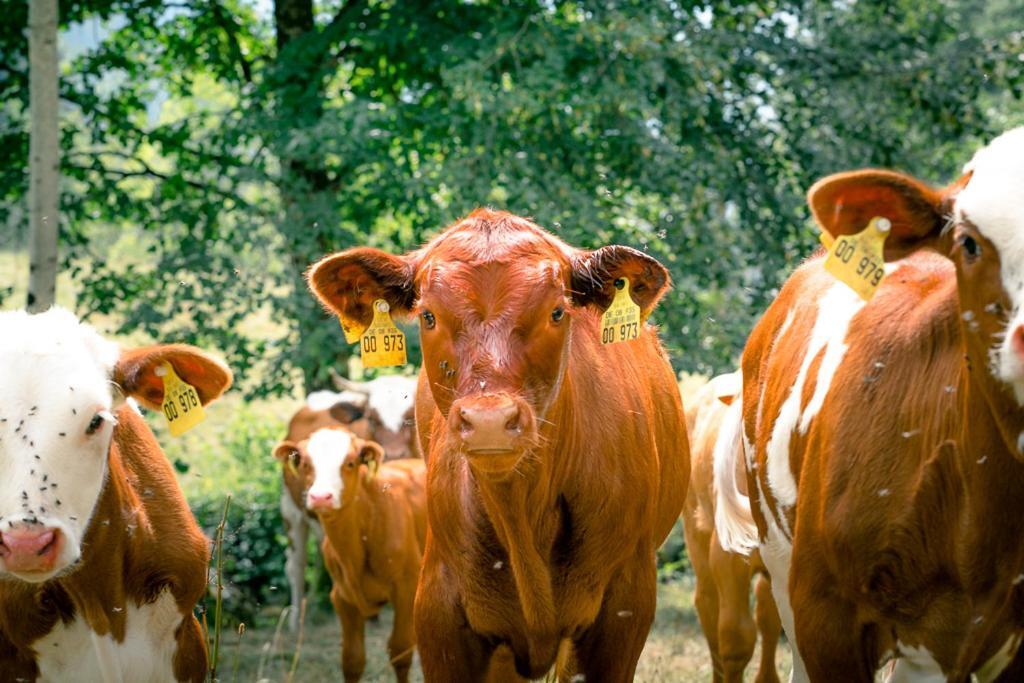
[34,591,184,683]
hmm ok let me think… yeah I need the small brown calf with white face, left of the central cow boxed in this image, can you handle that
[279,425,427,682]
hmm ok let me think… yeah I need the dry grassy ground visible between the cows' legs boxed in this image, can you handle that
[219,580,790,683]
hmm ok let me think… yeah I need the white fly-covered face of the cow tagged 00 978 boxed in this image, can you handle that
[0,308,119,582]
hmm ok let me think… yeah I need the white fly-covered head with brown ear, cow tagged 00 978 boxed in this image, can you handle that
[0,308,231,583]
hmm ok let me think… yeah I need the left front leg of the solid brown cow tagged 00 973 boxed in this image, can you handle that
[413,565,494,683]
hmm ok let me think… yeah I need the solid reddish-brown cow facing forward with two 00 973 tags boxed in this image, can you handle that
[307,209,689,681]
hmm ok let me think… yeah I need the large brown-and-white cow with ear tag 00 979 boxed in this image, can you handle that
[720,129,1024,681]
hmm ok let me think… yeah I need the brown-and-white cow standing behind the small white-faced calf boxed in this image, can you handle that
[275,376,418,631]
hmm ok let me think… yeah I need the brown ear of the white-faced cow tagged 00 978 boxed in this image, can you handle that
[113,344,231,411]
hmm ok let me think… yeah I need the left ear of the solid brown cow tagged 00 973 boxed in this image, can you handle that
[306,247,416,327]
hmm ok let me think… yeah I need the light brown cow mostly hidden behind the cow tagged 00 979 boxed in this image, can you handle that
[683,373,782,683]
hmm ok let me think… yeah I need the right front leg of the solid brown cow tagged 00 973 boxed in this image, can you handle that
[573,548,657,682]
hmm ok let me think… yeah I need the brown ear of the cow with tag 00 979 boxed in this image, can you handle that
[807,169,970,261]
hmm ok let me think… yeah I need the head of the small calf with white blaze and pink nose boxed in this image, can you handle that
[274,426,384,513]
